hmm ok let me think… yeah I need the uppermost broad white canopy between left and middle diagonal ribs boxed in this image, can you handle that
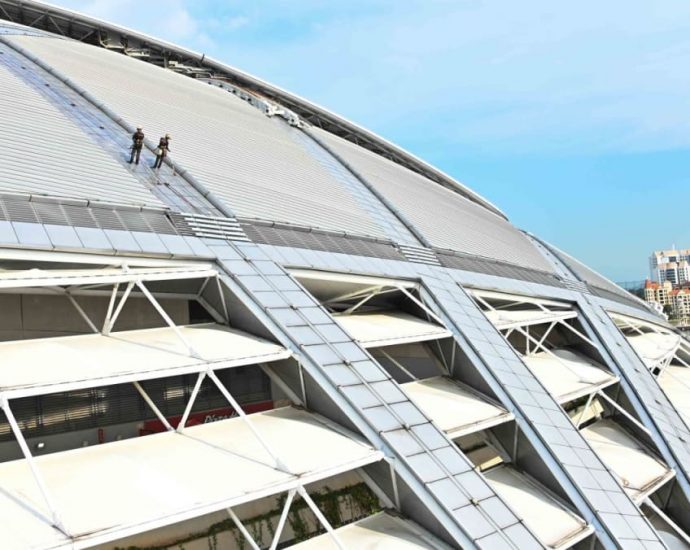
[335,311,452,348]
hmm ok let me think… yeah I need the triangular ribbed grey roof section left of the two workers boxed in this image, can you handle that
[0,50,162,206]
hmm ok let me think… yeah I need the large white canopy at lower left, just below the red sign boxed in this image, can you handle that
[0,407,382,549]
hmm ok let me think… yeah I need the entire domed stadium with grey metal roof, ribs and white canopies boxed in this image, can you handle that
[0,0,690,549]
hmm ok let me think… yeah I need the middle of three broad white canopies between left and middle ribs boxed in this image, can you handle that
[402,376,513,439]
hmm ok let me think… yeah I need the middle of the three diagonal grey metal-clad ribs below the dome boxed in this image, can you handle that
[422,269,659,547]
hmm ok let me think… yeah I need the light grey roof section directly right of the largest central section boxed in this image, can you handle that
[310,129,553,272]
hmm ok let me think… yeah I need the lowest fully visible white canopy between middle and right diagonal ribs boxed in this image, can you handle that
[581,419,673,502]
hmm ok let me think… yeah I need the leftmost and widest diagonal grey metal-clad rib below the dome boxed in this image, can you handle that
[206,243,541,548]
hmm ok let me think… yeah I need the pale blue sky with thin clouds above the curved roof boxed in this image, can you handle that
[54,0,690,281]
